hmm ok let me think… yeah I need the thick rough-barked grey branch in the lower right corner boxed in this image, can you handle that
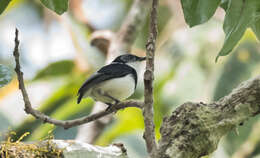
[158,76,260,158]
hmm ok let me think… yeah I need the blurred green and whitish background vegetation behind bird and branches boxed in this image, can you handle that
[0,0,260,158]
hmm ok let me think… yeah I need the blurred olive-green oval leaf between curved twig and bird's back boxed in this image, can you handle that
[34,60,75,80]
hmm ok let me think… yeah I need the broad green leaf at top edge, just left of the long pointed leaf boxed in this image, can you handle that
[181,0,221,27]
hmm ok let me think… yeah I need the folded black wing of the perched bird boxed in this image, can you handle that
[78,63,137,104]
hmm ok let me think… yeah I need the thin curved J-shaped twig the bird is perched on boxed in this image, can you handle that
[13,29,143,129]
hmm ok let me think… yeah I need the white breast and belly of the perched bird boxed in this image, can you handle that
[91,74,135,103]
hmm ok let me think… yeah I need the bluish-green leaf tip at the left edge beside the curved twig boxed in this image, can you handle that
[0,64,12,88]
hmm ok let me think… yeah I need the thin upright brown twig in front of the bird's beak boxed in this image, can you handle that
[143,0,158,158]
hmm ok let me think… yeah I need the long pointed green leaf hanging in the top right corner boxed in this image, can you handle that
[216,0,260,62]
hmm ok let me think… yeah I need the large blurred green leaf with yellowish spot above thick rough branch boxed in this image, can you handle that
[213,42,260,100]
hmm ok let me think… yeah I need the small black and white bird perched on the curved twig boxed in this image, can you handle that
[78,54,146,108]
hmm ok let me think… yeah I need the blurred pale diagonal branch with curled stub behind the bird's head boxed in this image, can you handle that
[91,0,151,58]
